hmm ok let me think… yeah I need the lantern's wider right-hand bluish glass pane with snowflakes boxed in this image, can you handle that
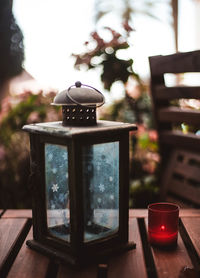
[83,142,119,241]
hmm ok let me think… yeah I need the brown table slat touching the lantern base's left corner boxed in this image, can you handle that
[7,229,49,278]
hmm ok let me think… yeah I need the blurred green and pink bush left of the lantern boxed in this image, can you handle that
[0,92,59,208]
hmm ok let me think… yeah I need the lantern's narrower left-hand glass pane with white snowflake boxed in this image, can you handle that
[45,144,70,241]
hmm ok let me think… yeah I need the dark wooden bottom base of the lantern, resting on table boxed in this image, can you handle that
[26,240,136,267]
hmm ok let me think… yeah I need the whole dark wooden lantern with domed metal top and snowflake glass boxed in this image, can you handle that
[23,82,136,266]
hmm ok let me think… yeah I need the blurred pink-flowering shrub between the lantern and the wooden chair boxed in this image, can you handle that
[72,9,160,207]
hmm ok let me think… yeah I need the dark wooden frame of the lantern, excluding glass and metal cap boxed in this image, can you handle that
[23,121,137,266]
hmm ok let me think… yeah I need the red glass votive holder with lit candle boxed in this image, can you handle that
[148,203,179,247]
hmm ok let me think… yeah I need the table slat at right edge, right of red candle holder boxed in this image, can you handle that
[182,217,200,257]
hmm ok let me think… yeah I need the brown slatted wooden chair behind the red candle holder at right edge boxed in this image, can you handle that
[149,51,200,206]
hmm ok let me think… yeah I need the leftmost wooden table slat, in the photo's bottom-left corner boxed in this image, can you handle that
[0,218,27,276]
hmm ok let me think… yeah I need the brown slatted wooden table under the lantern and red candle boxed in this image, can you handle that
[0,209,200,278]
